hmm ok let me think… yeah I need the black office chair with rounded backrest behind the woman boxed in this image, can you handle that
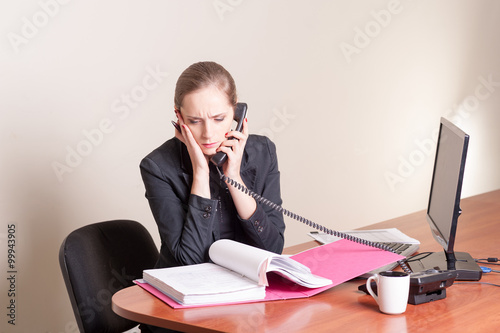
[59,220,158,333]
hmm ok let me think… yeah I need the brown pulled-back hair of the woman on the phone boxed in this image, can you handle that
[174,61,238,110]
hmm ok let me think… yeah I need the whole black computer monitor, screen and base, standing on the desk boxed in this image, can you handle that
[408,118,482,281]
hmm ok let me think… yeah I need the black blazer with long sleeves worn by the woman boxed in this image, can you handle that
[140,135,285,267]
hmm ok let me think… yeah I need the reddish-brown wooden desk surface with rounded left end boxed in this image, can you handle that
[112,190,500,332]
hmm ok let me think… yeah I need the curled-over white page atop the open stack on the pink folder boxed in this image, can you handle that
[208,239,277,285]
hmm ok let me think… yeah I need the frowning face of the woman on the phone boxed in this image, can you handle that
[180,86,234,156]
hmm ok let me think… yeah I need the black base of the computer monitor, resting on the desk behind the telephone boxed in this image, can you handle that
[408,251,483,281]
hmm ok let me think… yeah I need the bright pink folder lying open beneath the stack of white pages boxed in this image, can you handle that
[136,239,404,309]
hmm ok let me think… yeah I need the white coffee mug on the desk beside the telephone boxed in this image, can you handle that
[366,271,410,314]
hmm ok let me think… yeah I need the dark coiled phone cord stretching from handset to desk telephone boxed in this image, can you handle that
[217,167,412,274]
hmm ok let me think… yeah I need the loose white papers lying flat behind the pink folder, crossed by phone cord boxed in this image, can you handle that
[309,228,420,244]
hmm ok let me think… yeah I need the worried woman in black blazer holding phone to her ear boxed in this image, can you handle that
[140,62,285,267]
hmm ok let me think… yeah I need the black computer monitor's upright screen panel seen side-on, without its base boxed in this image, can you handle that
[427,118,469,252]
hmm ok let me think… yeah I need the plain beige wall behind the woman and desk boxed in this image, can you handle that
[0,0,500,332]
